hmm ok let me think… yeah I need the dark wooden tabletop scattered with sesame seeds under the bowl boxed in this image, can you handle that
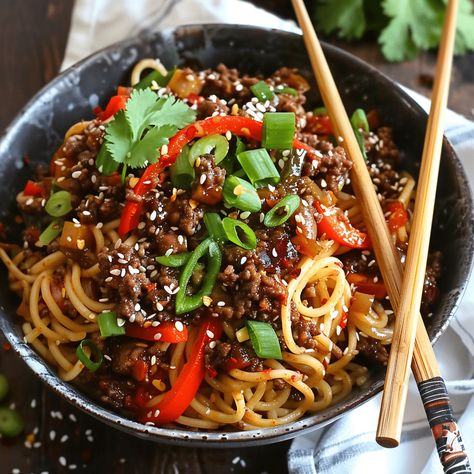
[0,0,474,474]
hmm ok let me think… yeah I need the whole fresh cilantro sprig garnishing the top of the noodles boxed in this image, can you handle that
[96,89,196,175]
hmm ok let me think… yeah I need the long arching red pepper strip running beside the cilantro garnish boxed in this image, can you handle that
[118,115,314,235]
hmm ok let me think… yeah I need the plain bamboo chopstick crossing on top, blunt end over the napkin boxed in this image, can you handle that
[376,0,458,445]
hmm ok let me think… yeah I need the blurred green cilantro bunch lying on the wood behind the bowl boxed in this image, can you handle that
[313,0,474,61]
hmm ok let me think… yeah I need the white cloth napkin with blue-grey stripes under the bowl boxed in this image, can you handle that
[63,0,474,474]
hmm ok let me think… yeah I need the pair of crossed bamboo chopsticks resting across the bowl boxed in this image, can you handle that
[292,0,471,472]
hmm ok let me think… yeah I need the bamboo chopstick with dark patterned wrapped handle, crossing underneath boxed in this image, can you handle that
[292,0,471,472]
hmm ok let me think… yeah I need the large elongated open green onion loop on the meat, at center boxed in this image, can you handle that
[175,238,222,314]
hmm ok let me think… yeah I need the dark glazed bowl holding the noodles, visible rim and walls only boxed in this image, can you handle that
[0,25,474,447]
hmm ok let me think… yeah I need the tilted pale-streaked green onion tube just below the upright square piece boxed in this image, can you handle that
[237,147,280,188]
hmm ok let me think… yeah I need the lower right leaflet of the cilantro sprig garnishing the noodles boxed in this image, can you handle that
[127,125,178,168]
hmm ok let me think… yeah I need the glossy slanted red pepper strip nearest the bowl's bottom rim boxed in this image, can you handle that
[140,318,222,425]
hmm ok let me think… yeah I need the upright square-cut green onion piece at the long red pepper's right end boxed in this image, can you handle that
[262,112,296,150]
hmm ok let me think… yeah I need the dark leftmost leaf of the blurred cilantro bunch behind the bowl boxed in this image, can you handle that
[314,0,366,39]
